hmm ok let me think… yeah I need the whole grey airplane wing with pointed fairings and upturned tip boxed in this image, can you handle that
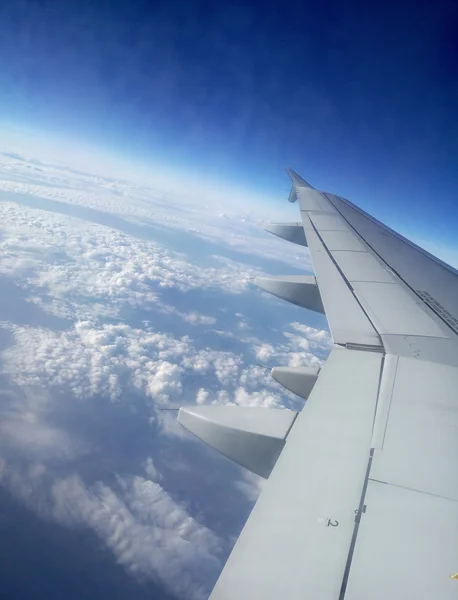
[179,170,458,600]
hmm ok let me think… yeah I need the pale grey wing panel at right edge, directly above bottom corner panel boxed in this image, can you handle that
[371,356,458,502]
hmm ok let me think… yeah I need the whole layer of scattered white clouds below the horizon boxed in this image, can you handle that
[0,149,331,598]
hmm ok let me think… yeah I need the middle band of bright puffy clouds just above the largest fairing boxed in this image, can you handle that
[3,321,322,406]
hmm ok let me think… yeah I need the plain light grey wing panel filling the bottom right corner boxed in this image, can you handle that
[348,481,458,600]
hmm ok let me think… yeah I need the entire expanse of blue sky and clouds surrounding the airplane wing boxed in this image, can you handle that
[0,0,458,600]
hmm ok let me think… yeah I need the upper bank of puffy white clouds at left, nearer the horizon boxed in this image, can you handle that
[0,203,296,328]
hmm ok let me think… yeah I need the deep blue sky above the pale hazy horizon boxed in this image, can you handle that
[0,0,458,244]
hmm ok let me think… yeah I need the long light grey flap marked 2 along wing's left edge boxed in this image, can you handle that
[211,348,382,600]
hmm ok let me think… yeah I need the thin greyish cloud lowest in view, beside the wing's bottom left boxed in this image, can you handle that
[51,475,225,599]
